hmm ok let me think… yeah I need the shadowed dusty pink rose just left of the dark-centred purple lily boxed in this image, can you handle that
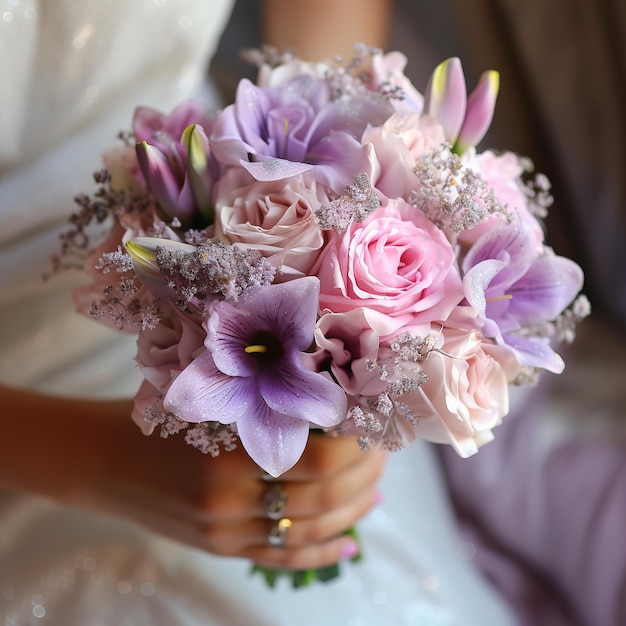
[132,300,206,434]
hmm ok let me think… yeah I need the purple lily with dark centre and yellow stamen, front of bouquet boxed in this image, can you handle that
[164,277,347,477]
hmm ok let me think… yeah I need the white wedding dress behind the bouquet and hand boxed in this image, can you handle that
[0,0,515,626]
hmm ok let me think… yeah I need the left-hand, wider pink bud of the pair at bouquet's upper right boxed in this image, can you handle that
[424,57,467,144]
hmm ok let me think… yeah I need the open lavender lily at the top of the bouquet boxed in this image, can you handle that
[210,78,392,193]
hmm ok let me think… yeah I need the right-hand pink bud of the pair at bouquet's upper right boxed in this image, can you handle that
[454,70,500,154]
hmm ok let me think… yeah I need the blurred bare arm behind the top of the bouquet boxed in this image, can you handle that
[263,0,392,61]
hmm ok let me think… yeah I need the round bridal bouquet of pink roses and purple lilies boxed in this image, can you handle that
[56,47,588,584]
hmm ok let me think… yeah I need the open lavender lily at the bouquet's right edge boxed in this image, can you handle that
[463,221,583,373]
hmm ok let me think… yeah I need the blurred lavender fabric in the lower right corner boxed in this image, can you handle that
[441,376,626,626]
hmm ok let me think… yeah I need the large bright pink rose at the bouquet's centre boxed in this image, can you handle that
[313,200,463,336]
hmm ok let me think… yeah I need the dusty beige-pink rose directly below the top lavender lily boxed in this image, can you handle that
[215,171,329,280]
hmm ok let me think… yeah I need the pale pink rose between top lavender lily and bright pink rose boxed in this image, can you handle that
[361,113,445,200]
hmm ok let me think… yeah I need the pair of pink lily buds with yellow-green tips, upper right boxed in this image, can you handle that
[424,57,500,154]
